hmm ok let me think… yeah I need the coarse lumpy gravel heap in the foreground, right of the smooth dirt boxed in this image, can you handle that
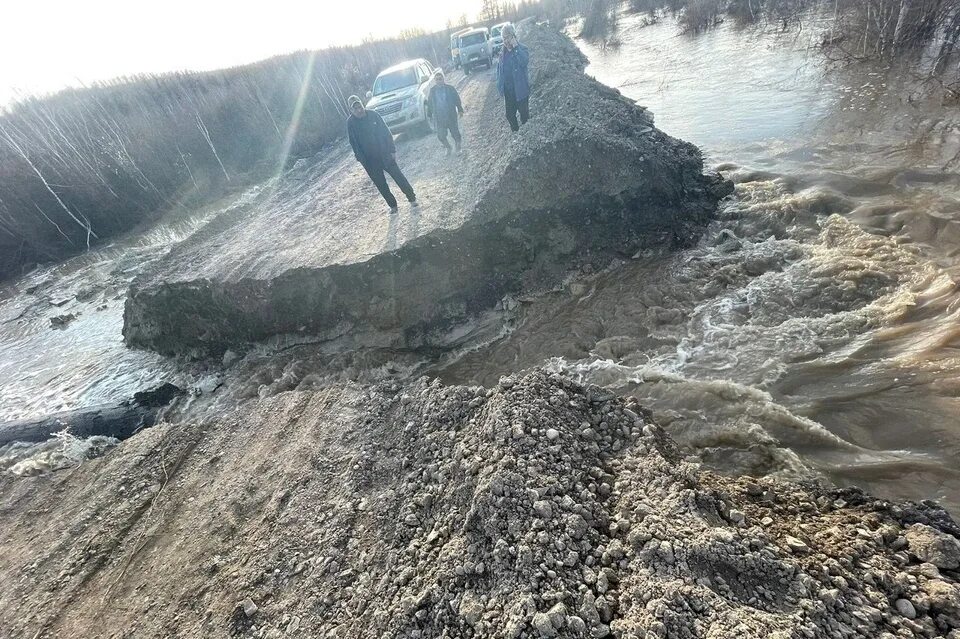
[244,372,960,639]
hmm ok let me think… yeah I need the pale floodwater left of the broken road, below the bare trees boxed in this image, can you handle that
[0,202,240,421]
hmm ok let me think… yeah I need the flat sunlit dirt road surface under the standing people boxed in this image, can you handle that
[146,71,509,281]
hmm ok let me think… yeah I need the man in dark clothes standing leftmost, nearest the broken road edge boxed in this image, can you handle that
[347,95,417,213]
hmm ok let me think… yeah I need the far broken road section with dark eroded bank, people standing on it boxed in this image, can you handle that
[124,26,732,355]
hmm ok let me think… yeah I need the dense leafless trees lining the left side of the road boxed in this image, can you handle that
[0,34,420,277]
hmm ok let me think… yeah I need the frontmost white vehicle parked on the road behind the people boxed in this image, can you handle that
[366,58,433,133]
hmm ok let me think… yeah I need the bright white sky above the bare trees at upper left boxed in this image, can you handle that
[0,0,481,105]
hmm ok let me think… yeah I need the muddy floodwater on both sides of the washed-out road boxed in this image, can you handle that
[0,16,960,513]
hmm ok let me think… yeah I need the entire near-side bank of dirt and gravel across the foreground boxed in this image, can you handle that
[0,371,960,639]
